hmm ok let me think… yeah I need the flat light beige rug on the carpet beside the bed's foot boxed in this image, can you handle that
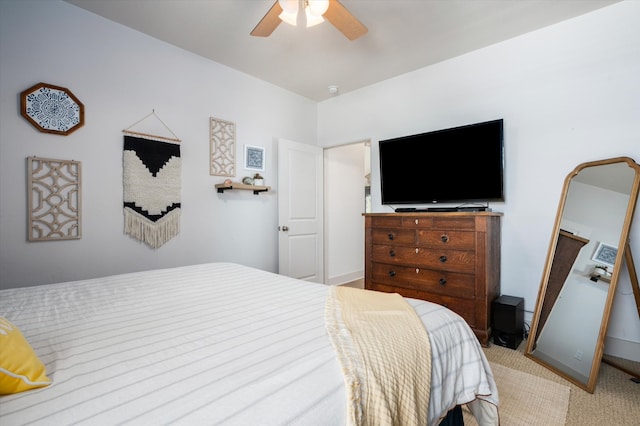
[463,363,570,426]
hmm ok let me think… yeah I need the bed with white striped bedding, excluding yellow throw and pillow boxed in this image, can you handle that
[0,263,498,426]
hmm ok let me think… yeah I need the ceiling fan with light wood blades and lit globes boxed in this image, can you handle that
[251,0,368,40]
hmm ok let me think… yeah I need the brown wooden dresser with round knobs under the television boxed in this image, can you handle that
[364,212,502,346]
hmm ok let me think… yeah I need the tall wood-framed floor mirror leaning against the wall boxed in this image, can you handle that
[525,157,640,392]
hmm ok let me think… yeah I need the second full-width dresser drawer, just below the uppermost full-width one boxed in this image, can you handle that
[371,263,476,299]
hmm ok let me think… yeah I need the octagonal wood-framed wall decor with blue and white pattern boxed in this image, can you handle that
[20,83,84,136]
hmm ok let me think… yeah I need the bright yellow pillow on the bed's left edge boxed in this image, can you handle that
[0,317,51,395]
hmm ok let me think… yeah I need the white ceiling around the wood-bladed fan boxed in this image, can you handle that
[66,0,620,101]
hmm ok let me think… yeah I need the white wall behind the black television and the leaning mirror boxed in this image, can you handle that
[318,1,640,352]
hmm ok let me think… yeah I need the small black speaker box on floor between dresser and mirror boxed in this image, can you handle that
[491,296,524,349]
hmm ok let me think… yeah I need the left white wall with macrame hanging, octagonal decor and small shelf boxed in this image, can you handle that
[0,0,317,288]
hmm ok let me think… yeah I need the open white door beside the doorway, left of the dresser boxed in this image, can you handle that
[278,139,324,283]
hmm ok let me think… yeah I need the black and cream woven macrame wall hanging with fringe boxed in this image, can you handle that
[122,111,182,249]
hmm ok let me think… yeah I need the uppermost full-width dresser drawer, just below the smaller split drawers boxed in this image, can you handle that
[371,244,476,274]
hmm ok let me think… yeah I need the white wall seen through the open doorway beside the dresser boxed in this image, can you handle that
[324,142,365,285]
